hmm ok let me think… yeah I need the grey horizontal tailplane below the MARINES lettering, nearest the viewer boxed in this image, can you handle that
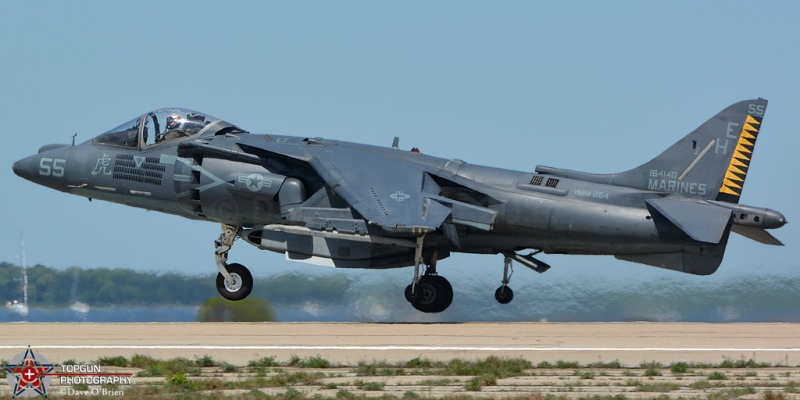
[646,197,731,244]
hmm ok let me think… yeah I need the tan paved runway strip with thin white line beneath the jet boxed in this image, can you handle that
[0,323,800,366]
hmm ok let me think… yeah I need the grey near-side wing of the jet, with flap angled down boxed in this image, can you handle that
[239,139,497,234]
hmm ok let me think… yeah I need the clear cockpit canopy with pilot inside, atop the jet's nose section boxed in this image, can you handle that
[94,108,244,148]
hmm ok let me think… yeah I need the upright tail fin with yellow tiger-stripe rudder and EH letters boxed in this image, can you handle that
[612,98,767,203]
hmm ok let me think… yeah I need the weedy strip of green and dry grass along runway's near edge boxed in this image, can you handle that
[0,356,800,400]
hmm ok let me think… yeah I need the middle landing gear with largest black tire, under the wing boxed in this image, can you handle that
[405,236,453,313]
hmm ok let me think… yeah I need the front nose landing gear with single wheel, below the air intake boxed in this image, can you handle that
[214,224,253,300]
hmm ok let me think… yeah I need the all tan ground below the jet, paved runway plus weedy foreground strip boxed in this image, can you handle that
[0,323,800,399]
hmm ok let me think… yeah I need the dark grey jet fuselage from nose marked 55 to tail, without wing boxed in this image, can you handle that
[15,134,720,254]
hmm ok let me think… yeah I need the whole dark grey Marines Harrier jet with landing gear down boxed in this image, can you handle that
[14,99,786,312]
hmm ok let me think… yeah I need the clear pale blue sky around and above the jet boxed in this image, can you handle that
[0,1,800,291]
